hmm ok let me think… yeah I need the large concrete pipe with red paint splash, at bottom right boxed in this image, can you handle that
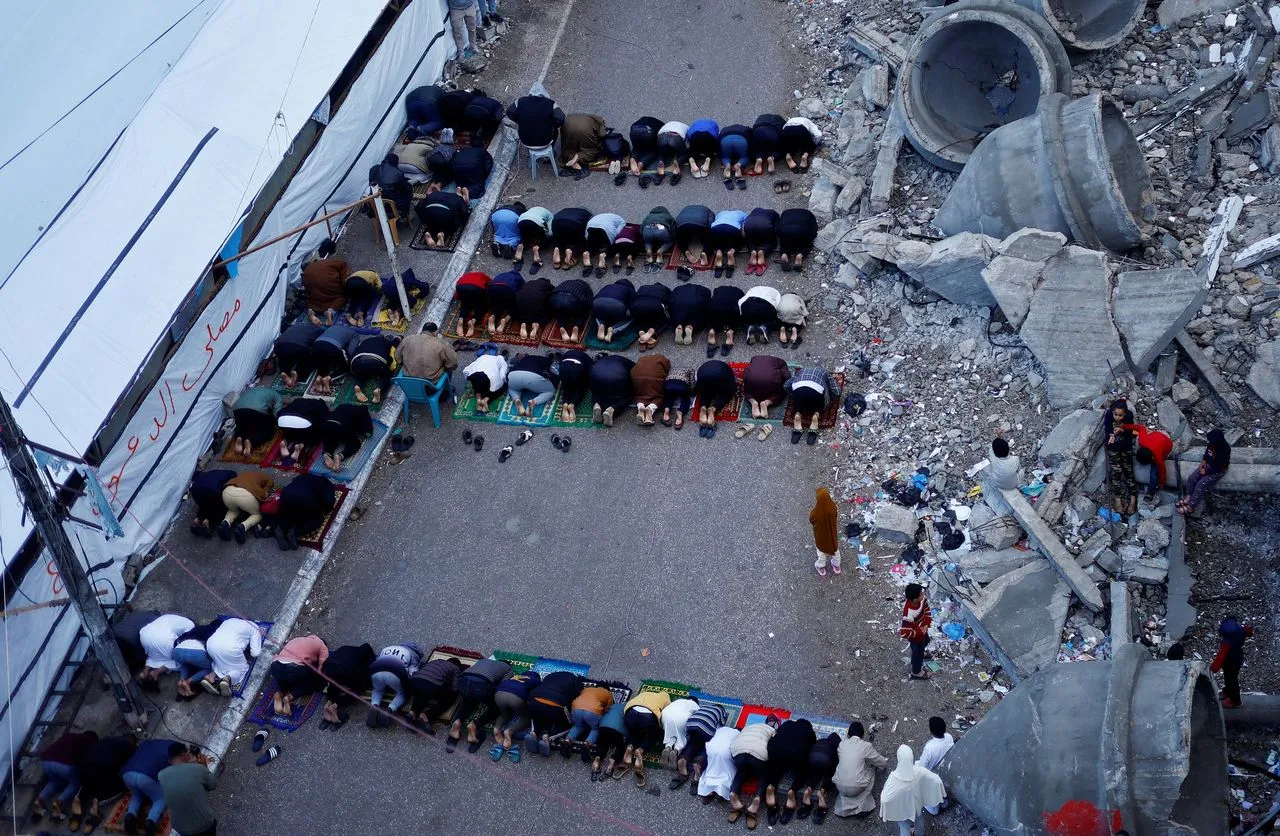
[938,644,1228,836]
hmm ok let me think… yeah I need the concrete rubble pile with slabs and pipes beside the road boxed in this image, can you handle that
[773,0,1280,832]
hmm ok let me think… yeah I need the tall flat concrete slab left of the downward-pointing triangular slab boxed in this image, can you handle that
[1018,246,1124,408]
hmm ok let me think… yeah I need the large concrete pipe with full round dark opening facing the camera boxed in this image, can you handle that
[897,0,1071,172]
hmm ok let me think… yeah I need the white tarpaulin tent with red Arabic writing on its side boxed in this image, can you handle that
[0,0,453,788]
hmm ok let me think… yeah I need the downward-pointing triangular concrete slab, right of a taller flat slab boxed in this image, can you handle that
[1111,268,1208,374]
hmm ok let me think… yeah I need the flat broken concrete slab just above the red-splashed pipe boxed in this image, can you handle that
[960,559,1071,684]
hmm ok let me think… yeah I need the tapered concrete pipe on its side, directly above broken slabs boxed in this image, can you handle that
[933,93,1152,251]
